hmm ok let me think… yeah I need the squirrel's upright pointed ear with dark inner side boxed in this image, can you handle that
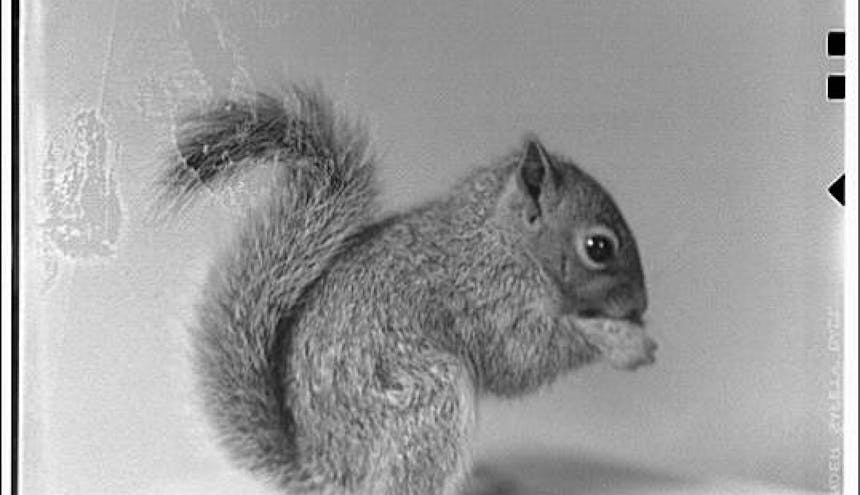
[516,134,559,223]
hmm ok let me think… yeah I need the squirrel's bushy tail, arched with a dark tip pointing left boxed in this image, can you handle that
[160,87,375,485]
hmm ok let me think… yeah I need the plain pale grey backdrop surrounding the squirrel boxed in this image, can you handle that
[21,0,842,494]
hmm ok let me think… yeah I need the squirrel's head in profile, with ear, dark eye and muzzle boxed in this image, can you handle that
[495,135,647,323]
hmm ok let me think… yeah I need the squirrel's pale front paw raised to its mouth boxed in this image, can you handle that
[577,318,657,370]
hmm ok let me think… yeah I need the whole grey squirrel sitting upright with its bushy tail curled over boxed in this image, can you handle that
[156,85,656,495]
